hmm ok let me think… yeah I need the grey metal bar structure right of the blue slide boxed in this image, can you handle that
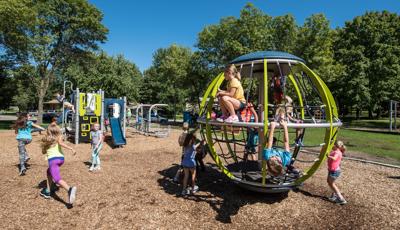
[133,104,171,137]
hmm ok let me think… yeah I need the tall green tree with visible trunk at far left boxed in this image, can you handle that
[0,0,107,123]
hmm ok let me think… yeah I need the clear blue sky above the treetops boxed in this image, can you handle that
[89,0,400,71]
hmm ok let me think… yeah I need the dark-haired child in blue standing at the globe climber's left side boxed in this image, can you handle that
[181,133,199,196]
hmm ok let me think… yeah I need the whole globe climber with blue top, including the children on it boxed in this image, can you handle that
[197,51,342,193]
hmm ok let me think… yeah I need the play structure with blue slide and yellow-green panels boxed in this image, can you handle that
[60,81,126,146]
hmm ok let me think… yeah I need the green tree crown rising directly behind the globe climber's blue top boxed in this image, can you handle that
[196,3,274,69]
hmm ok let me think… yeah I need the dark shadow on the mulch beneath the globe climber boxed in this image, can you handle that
[158,165,288,223]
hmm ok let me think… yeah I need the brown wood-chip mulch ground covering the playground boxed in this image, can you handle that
[0,128,400,229]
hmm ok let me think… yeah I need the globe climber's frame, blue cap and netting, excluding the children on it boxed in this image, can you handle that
[197,51,342,193]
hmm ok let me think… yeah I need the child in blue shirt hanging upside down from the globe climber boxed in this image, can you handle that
[263,109,299,176]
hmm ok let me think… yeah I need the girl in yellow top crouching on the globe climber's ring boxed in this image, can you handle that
[216,64,246,123]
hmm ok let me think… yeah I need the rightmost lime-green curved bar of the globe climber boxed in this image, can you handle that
[295,63,337,184]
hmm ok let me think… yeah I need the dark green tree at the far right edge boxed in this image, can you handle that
[335,11,400,118]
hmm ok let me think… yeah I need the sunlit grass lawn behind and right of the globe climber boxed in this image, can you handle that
[300,129,400,160]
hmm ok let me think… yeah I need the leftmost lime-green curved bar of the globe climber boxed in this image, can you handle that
[203,73,234,179]
